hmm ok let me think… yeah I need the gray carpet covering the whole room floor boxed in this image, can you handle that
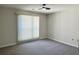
[0,39,78,55]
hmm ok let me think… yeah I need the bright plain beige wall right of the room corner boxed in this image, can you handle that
[48,7,79,47]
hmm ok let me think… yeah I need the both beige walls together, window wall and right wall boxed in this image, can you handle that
[0,6,79,47]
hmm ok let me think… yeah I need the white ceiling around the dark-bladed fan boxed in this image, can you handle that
[0,4,78,14]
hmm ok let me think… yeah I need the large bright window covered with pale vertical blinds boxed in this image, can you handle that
[18,15,39,41]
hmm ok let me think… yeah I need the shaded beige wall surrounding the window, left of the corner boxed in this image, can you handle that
[0,7,47,47]
